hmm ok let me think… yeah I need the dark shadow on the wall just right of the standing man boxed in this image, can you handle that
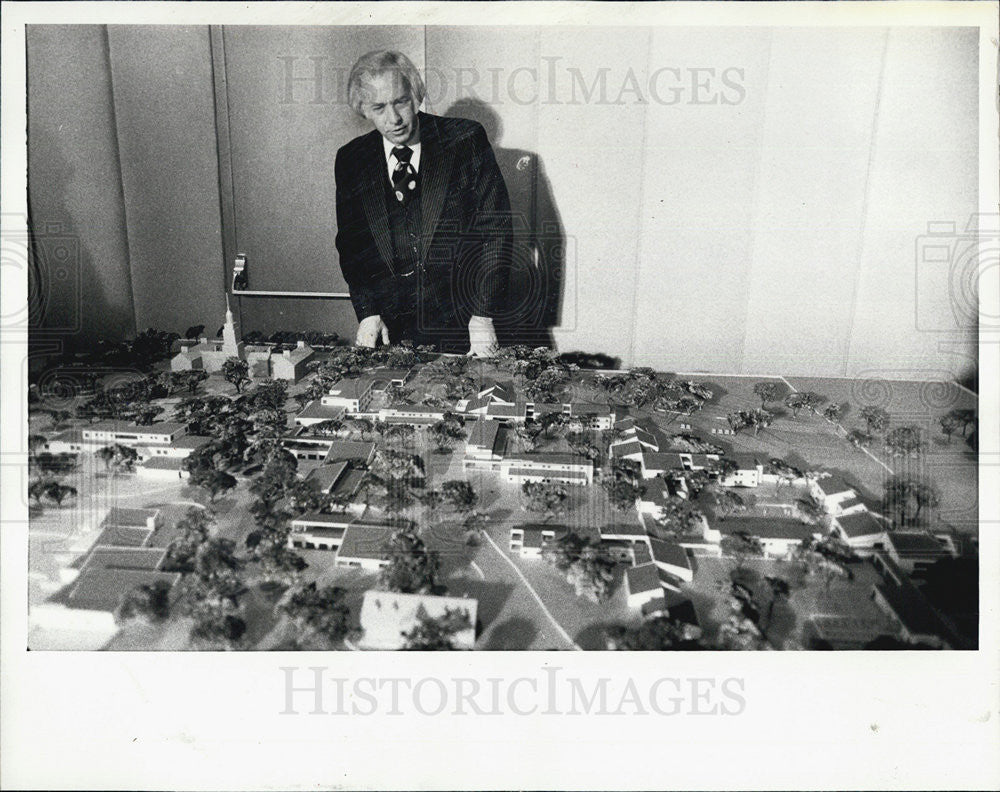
[444,98,566,347]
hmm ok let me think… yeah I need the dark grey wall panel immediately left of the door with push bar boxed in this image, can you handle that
[108,25,225,333]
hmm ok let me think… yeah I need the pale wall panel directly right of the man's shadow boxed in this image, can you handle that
[538,28,650,357]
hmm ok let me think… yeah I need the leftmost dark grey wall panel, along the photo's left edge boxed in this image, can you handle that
[26,25,135,349]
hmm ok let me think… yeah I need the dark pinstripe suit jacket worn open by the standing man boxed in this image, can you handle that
[335,113,511,334]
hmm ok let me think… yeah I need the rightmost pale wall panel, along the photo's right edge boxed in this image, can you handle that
[846,28,979,379]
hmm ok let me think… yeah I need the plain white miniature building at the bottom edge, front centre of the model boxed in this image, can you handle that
[358,591,478,650]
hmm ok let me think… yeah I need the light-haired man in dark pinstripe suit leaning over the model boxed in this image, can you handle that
[335,50,511,355]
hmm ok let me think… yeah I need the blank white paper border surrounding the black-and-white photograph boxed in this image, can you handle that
[0,2,1000,789]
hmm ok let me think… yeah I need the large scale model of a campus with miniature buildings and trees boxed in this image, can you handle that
[27,304,979,650]
